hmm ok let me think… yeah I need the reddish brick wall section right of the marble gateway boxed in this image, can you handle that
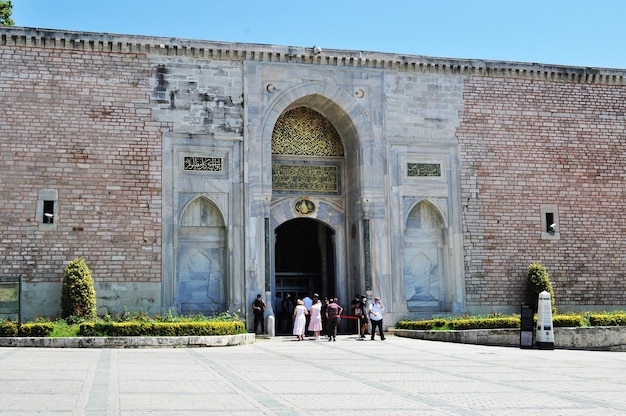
[457,77,626,308]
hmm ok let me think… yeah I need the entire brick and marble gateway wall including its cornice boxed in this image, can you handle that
[0,27,626,329]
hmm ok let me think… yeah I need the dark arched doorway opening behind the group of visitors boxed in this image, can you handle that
[274,218,337,334]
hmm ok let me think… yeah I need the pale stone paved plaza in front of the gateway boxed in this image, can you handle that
[0,334,626,416]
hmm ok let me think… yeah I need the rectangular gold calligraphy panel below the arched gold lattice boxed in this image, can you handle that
[272,162,339,193]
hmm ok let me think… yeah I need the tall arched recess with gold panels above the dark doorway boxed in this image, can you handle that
[271,105,345,334]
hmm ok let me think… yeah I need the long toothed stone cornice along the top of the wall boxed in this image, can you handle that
[0,26,626,85]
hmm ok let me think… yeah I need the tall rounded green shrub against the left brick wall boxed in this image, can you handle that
[61,258,96,322]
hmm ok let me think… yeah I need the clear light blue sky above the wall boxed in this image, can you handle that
[12,0,626,69]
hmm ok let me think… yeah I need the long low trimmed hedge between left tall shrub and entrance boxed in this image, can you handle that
[79,322,246,337]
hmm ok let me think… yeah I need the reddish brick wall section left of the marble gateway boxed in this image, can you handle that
[0,47,164,290]
